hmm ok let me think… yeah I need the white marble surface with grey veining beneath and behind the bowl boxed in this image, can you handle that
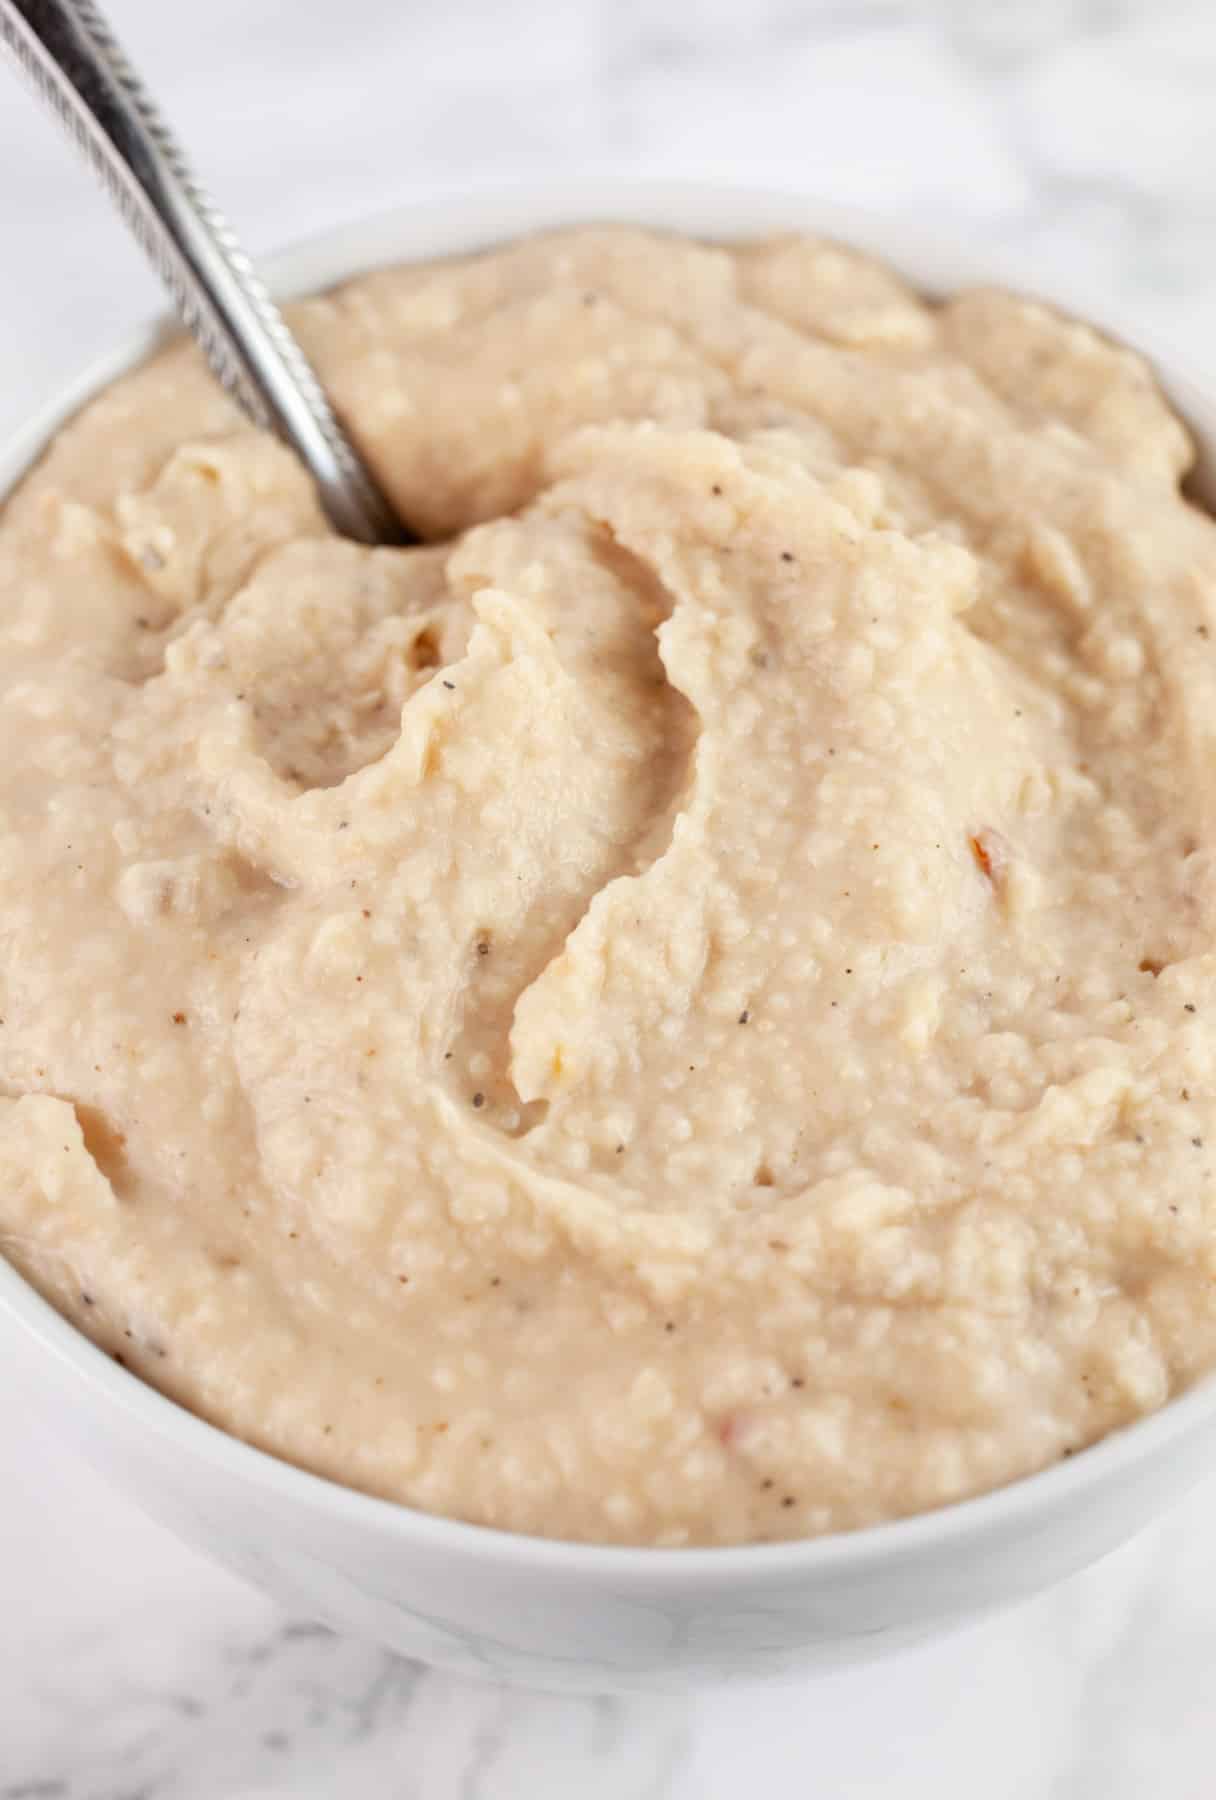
[0,0,1216,1800]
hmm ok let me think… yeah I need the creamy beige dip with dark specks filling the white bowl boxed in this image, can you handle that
[0,229,1216,1544]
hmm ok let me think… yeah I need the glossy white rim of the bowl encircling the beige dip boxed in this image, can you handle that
[0,178,1216,1588]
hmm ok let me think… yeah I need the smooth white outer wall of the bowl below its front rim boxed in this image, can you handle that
[16,1316,1216,1692]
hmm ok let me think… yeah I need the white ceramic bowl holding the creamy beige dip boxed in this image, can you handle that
[0,184,1216,1690]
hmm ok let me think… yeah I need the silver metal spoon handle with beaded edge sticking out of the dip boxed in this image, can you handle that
[0,0,410,544]
